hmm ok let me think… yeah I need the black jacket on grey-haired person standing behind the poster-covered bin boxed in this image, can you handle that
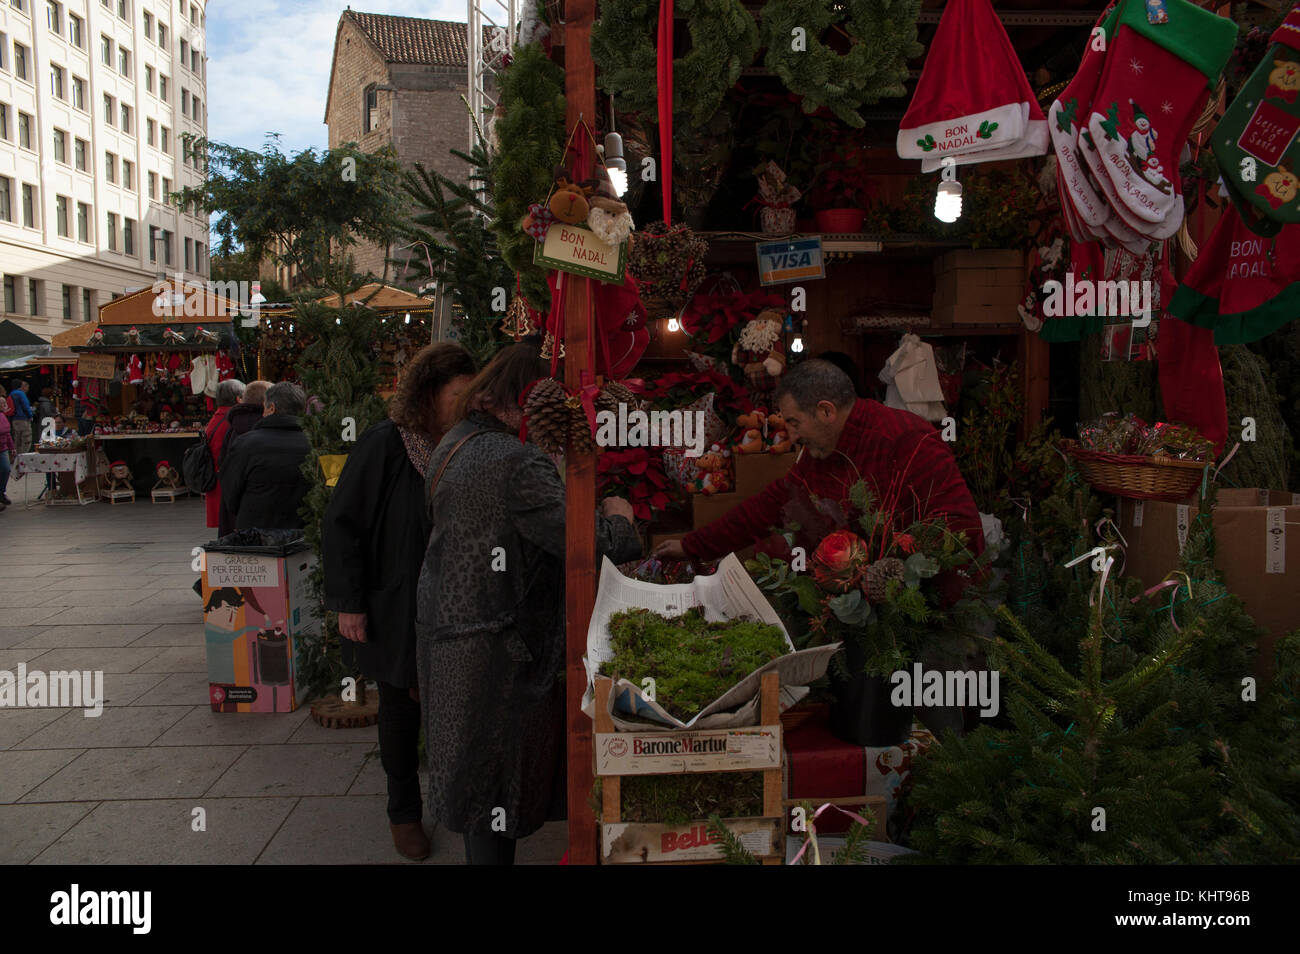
[221,415,309,530]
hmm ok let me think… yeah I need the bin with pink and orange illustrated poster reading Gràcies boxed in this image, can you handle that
[203,550,317,712]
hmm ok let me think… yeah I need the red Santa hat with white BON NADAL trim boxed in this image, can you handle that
[898,0,1048,173]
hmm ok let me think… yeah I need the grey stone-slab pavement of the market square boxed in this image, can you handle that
[0,488,566,864]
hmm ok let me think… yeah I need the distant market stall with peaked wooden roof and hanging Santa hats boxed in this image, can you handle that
[70,281,238,499]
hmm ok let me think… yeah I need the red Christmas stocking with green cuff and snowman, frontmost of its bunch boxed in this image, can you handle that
[1088,0,1236,230]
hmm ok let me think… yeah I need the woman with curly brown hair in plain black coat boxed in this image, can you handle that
[321,343,475,859]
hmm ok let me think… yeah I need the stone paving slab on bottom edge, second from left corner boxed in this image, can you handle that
[33,798,298,864]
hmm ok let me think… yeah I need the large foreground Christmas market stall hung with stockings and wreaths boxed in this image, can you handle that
[480,0,1300,863]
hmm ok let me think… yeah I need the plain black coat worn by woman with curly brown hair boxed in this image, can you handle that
[321,421,432,689]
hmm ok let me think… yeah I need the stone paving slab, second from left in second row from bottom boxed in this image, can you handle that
[20,745,244,805]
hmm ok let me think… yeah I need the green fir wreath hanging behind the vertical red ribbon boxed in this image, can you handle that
[592,0,759,126]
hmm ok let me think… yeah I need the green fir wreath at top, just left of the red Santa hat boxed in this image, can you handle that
[761,0,924,127]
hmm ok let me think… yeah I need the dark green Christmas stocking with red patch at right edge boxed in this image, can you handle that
[1212,5,1300,235]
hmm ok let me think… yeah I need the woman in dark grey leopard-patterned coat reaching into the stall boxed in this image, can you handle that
[416,343,641,864]
